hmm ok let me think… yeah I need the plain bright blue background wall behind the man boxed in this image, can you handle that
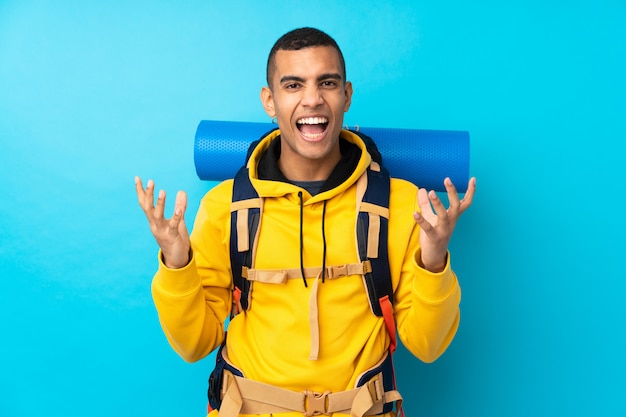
[0,0,626,417]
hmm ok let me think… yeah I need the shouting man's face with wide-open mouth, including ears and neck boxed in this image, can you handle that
[261,46,352,180]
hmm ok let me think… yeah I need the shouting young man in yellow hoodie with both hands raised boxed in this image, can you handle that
[136,28,475,417]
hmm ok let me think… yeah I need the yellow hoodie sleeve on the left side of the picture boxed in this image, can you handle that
[152,181,232,362]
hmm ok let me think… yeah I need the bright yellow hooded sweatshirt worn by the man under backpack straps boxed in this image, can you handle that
[152,131,460,415]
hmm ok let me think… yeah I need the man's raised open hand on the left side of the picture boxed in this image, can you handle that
[135,177,191,269]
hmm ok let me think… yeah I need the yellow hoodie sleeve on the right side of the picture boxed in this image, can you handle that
[389,179,461,362]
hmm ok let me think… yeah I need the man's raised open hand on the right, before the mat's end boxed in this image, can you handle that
[413,178,476,272]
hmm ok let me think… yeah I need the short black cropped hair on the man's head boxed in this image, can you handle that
[265,27,346,87]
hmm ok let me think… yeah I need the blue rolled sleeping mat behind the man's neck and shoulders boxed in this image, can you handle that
[194,120,469,192]
